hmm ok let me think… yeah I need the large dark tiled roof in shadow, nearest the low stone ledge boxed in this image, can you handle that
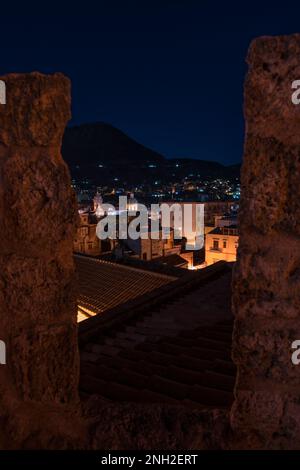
[80,272,235,408]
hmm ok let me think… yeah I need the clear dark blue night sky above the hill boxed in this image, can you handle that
[0,0,300,164]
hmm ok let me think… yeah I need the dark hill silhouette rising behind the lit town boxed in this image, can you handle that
[62,122,240,183]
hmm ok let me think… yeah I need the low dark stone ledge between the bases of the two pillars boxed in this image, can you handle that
[84,395,231,450]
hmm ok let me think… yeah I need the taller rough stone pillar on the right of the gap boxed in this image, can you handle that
[231,35,300,449]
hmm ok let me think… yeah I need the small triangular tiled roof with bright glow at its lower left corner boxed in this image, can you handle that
[74,255,176,319]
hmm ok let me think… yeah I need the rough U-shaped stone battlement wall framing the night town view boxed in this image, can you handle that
[4,35,300,449]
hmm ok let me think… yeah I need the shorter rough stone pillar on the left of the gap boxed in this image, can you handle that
[0,73,79,448]
